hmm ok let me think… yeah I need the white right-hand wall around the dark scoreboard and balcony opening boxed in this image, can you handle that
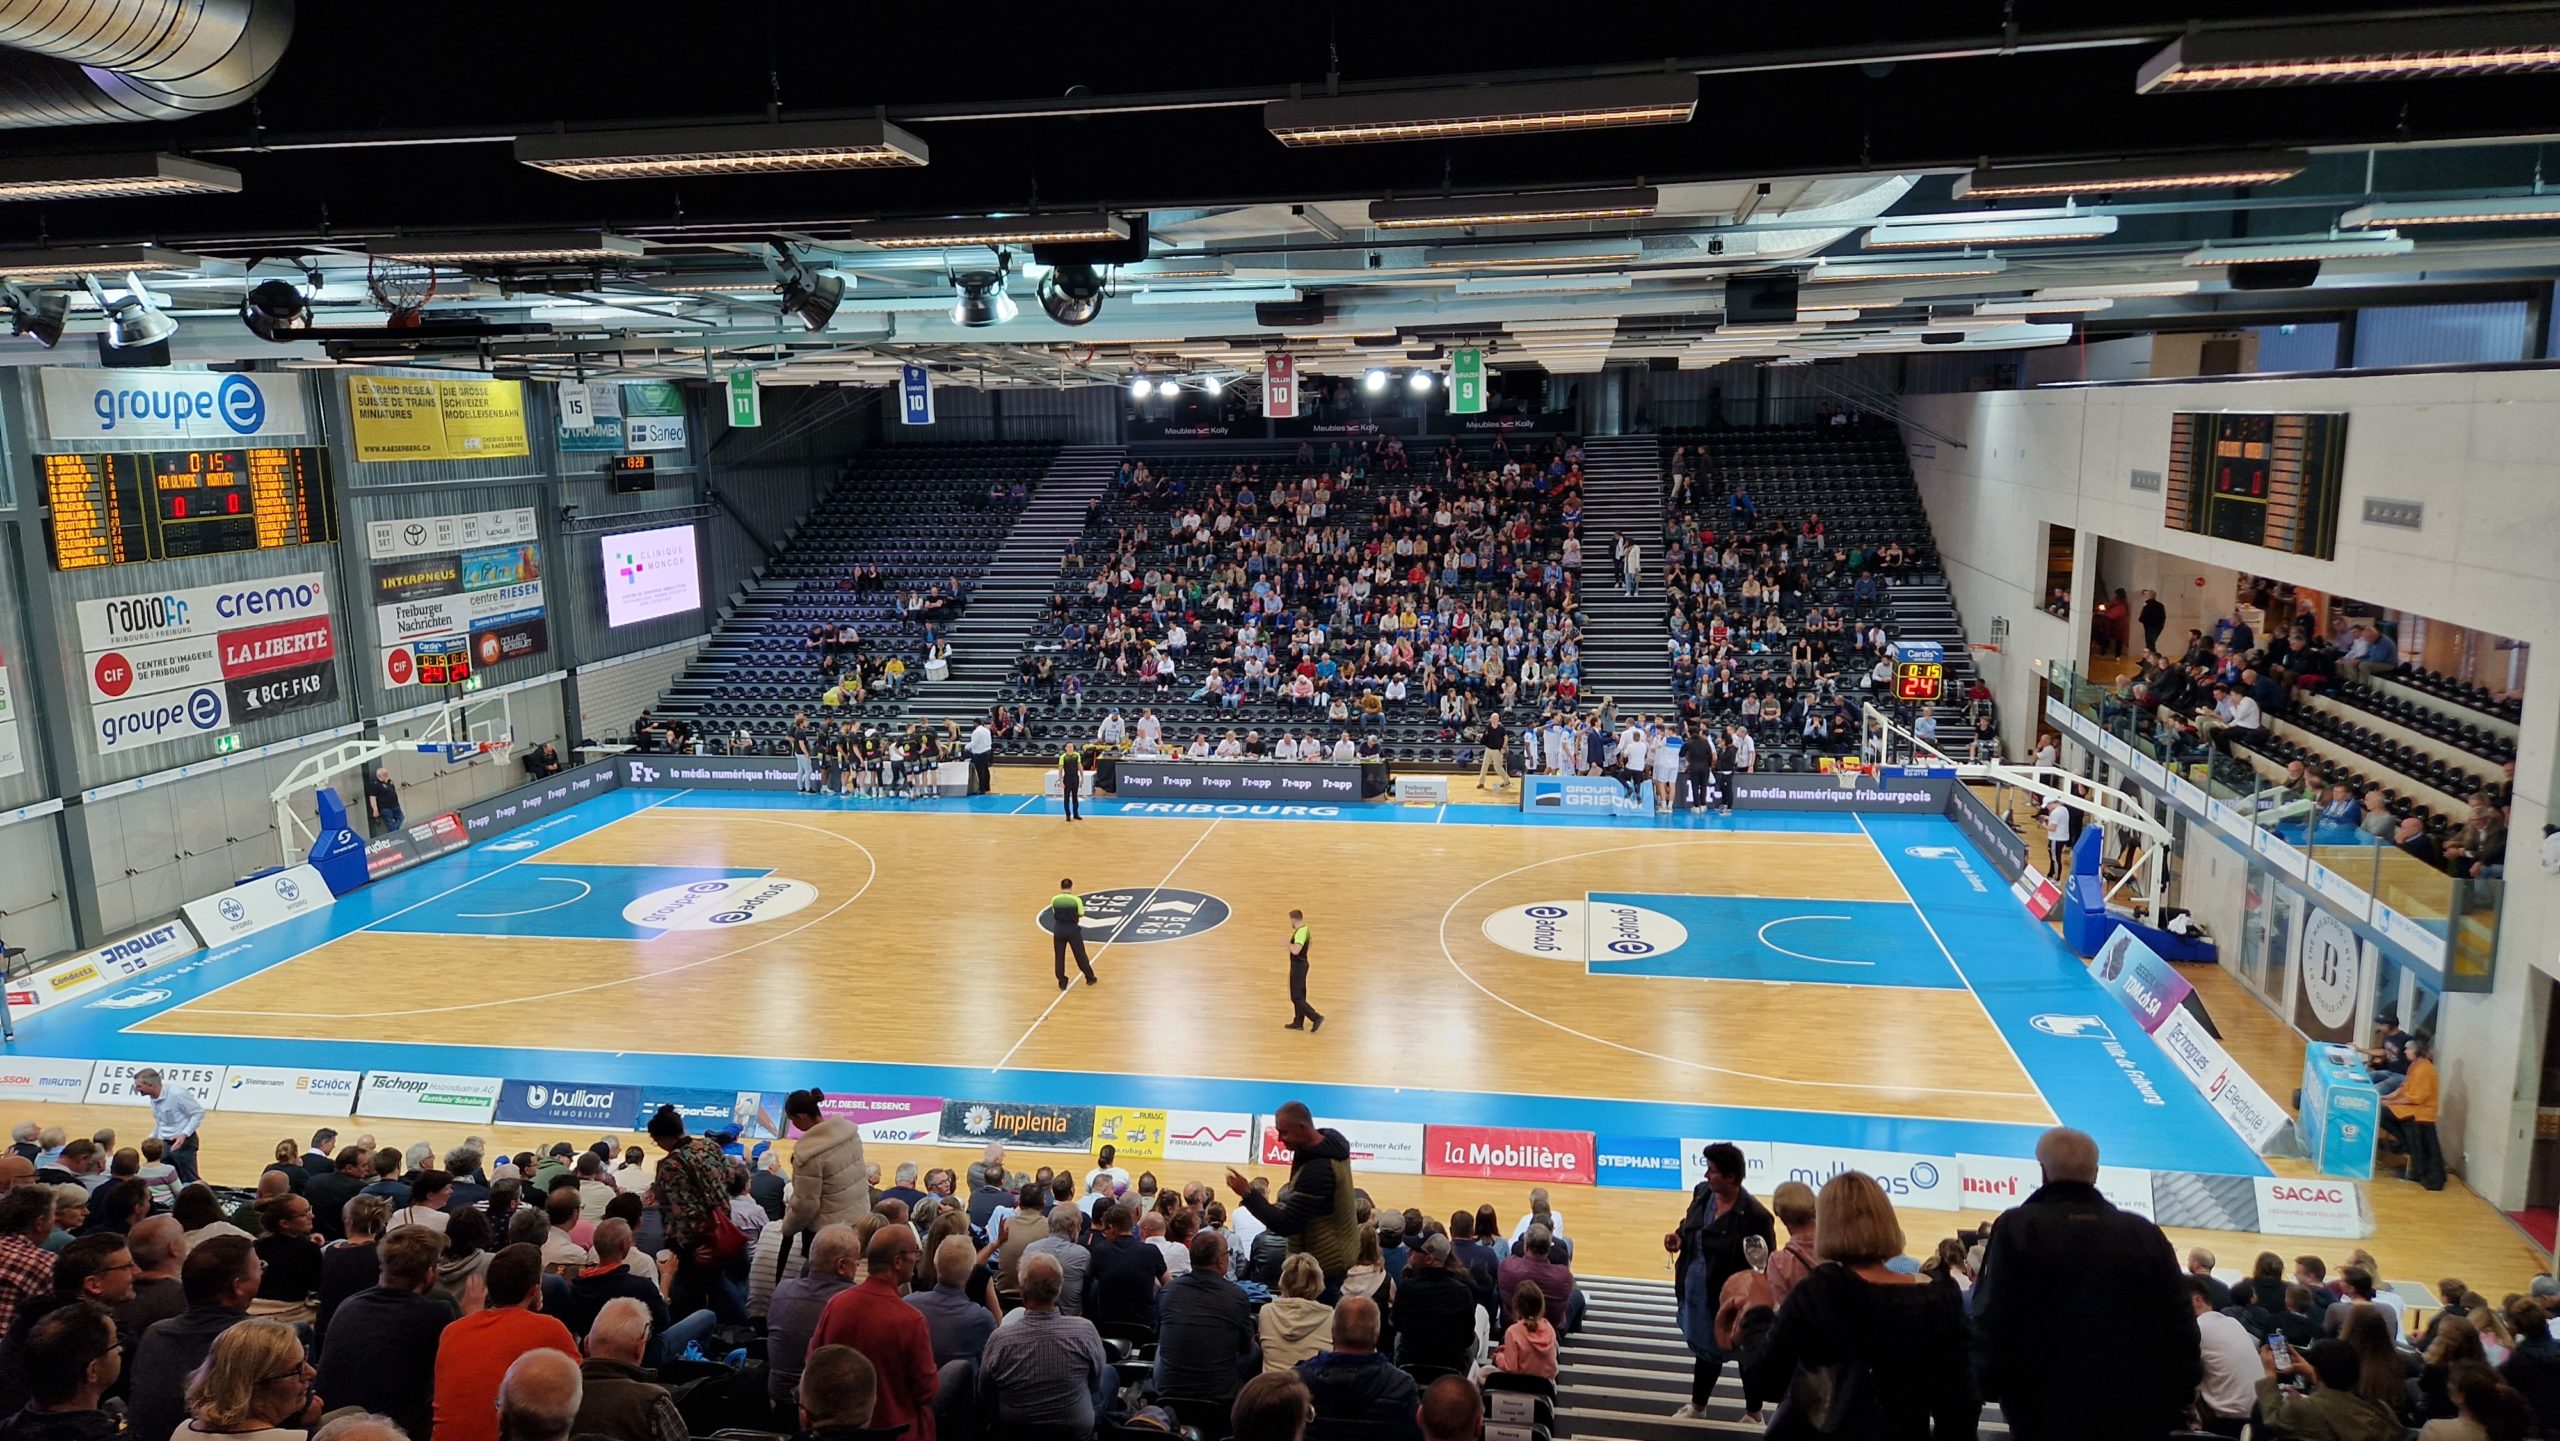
[1905,371,2560,1206]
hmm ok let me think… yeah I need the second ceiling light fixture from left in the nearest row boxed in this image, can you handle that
[515,120,932,179]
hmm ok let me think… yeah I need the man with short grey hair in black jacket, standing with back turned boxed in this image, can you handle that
[1966,1126,2204,1441]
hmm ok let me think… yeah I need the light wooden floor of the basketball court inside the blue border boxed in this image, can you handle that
[138,806,2053,1124]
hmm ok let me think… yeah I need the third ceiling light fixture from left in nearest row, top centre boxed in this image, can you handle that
[1262,74,1697,146]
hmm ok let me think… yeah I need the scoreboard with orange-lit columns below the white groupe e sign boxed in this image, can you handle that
[36,445,338,571]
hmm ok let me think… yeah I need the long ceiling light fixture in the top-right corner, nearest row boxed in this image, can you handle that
[2132,13,2560,95]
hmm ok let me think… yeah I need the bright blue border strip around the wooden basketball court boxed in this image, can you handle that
[8,791,2266,1175]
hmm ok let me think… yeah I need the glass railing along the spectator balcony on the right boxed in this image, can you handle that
[2045,663,2506,991]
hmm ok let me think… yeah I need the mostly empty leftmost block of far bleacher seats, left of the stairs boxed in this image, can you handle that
[658,445,1057,750]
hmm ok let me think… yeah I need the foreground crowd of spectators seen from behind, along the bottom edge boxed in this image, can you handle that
[0,1090,2560,1441]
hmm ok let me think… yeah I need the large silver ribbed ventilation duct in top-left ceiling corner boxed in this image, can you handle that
[0,0,294,131]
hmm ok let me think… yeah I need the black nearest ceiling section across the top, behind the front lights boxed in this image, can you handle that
[0,0,2560,248]
